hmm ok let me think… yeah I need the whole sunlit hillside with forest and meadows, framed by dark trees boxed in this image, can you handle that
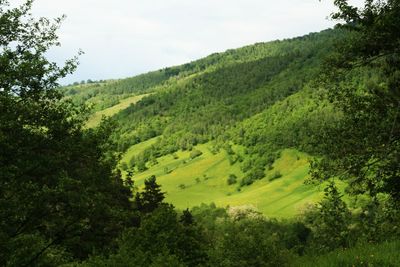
[63,30,346,216]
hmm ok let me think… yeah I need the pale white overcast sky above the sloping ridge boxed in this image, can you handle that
[22,0,362,83]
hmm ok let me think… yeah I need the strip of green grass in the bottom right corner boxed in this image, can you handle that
[291,240,400,267]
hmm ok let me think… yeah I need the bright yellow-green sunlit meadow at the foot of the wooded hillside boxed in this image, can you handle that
[122,143,321,217]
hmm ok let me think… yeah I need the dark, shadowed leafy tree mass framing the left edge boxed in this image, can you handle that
[0,0,134,266]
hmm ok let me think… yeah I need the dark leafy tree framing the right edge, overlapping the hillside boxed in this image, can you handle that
[312,1,400,200]
